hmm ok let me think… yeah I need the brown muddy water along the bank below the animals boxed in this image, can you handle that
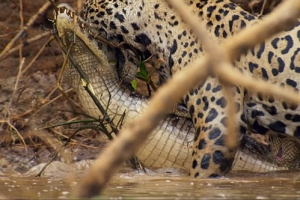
[0,161,300,199]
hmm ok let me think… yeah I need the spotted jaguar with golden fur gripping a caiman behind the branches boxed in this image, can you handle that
[58,0,300,178]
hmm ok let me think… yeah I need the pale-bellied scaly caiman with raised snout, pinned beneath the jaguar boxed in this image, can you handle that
[56,4,294,172]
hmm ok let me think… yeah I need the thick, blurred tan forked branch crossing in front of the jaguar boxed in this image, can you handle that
[78,0,300,197]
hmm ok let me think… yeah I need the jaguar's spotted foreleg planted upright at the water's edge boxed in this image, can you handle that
[189,79,242,178]
